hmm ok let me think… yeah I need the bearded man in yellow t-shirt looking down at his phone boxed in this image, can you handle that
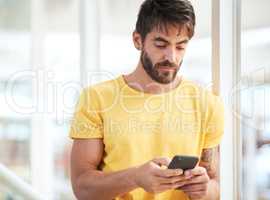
[70,0,223,200]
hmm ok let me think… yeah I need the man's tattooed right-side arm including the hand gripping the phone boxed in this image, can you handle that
[178,147,219,200]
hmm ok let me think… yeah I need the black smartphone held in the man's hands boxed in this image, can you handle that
[168,155,199,171]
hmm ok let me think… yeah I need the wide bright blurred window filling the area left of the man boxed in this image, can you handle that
[0,0,80,199]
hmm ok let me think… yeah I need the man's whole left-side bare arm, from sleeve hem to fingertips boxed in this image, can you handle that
[71,139,187,200]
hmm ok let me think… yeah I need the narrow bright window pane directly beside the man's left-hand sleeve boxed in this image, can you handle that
[43,0,80,199]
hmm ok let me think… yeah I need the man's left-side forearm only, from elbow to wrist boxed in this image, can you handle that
[73,168,137,200]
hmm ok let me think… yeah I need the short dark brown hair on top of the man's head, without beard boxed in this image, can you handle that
[136,0,195,40]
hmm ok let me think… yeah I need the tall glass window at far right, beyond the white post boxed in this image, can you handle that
[239,0,270,200]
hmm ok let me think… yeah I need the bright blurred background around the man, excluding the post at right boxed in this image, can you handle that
[0,0,270,200]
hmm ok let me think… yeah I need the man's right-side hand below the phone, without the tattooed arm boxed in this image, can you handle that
[179,167,210,200]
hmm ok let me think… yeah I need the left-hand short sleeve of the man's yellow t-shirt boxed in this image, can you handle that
[69,87,103,139]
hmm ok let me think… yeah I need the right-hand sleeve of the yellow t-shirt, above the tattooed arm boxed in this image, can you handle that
[203,95,224,149]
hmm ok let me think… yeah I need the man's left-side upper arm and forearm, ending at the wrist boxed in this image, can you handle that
[71,139,136,200]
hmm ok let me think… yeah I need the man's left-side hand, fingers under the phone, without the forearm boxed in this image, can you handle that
[135,158,189,193]
